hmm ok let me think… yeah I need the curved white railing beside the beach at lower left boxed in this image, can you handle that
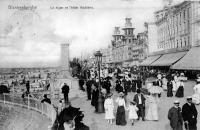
[0,93,57,124]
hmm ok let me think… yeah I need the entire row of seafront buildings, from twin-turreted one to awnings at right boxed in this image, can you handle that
[97,1,200,70]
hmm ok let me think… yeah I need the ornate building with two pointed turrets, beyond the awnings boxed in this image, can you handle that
[101,18,148,66]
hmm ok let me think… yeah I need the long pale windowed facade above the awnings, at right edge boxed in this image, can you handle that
[155,1,200,51]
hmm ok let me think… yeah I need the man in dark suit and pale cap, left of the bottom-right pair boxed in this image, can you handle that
[168,100,183,130]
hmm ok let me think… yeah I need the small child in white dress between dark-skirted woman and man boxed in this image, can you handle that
[127,101,138,125]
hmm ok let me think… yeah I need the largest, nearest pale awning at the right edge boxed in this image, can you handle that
[171,47,200,70]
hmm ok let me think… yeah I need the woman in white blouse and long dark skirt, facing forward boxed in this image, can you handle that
[116,92,126,126]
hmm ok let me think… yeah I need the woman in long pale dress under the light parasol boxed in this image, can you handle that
[146,94,158,121]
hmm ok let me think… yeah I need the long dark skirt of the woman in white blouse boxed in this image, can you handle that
[116,106,126,125]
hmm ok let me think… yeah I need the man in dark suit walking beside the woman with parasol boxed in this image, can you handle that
[133,89,146,121]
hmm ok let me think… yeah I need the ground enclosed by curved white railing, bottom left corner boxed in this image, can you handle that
[0,103,51,130]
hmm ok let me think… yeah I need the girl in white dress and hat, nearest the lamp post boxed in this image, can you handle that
[104,93,115,124]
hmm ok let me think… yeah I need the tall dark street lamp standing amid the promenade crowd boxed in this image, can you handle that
[94,51,104,113]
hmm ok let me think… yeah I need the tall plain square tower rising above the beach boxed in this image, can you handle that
[60,43,69,71]
